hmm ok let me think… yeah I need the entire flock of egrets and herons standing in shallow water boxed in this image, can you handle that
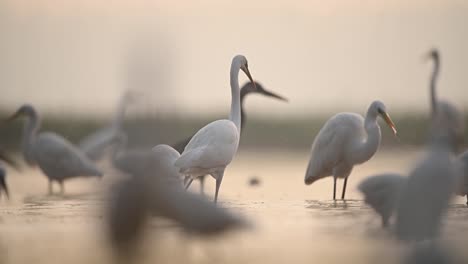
[0,49,468,260]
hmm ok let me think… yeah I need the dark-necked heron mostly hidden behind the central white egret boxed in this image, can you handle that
[173,82,288,193]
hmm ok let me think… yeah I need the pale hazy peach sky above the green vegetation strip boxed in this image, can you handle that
[0,0,468,117]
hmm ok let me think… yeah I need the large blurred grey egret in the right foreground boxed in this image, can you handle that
[395,112,459,241]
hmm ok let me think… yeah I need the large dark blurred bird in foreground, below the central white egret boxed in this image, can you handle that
[108,145,245,253]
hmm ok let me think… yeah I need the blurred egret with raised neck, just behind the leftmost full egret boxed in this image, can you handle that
[78,91,135,161]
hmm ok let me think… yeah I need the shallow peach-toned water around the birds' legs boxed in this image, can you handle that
[0,150,468,264]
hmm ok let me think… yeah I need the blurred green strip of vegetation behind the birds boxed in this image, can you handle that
[0,111,460,151]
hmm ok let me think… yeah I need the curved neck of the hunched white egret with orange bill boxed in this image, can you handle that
[351,110,381,164]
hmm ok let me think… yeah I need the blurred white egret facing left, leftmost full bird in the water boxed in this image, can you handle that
[9,104,102,194]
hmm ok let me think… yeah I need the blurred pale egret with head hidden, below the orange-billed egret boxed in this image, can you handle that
[358,173,406,227]
